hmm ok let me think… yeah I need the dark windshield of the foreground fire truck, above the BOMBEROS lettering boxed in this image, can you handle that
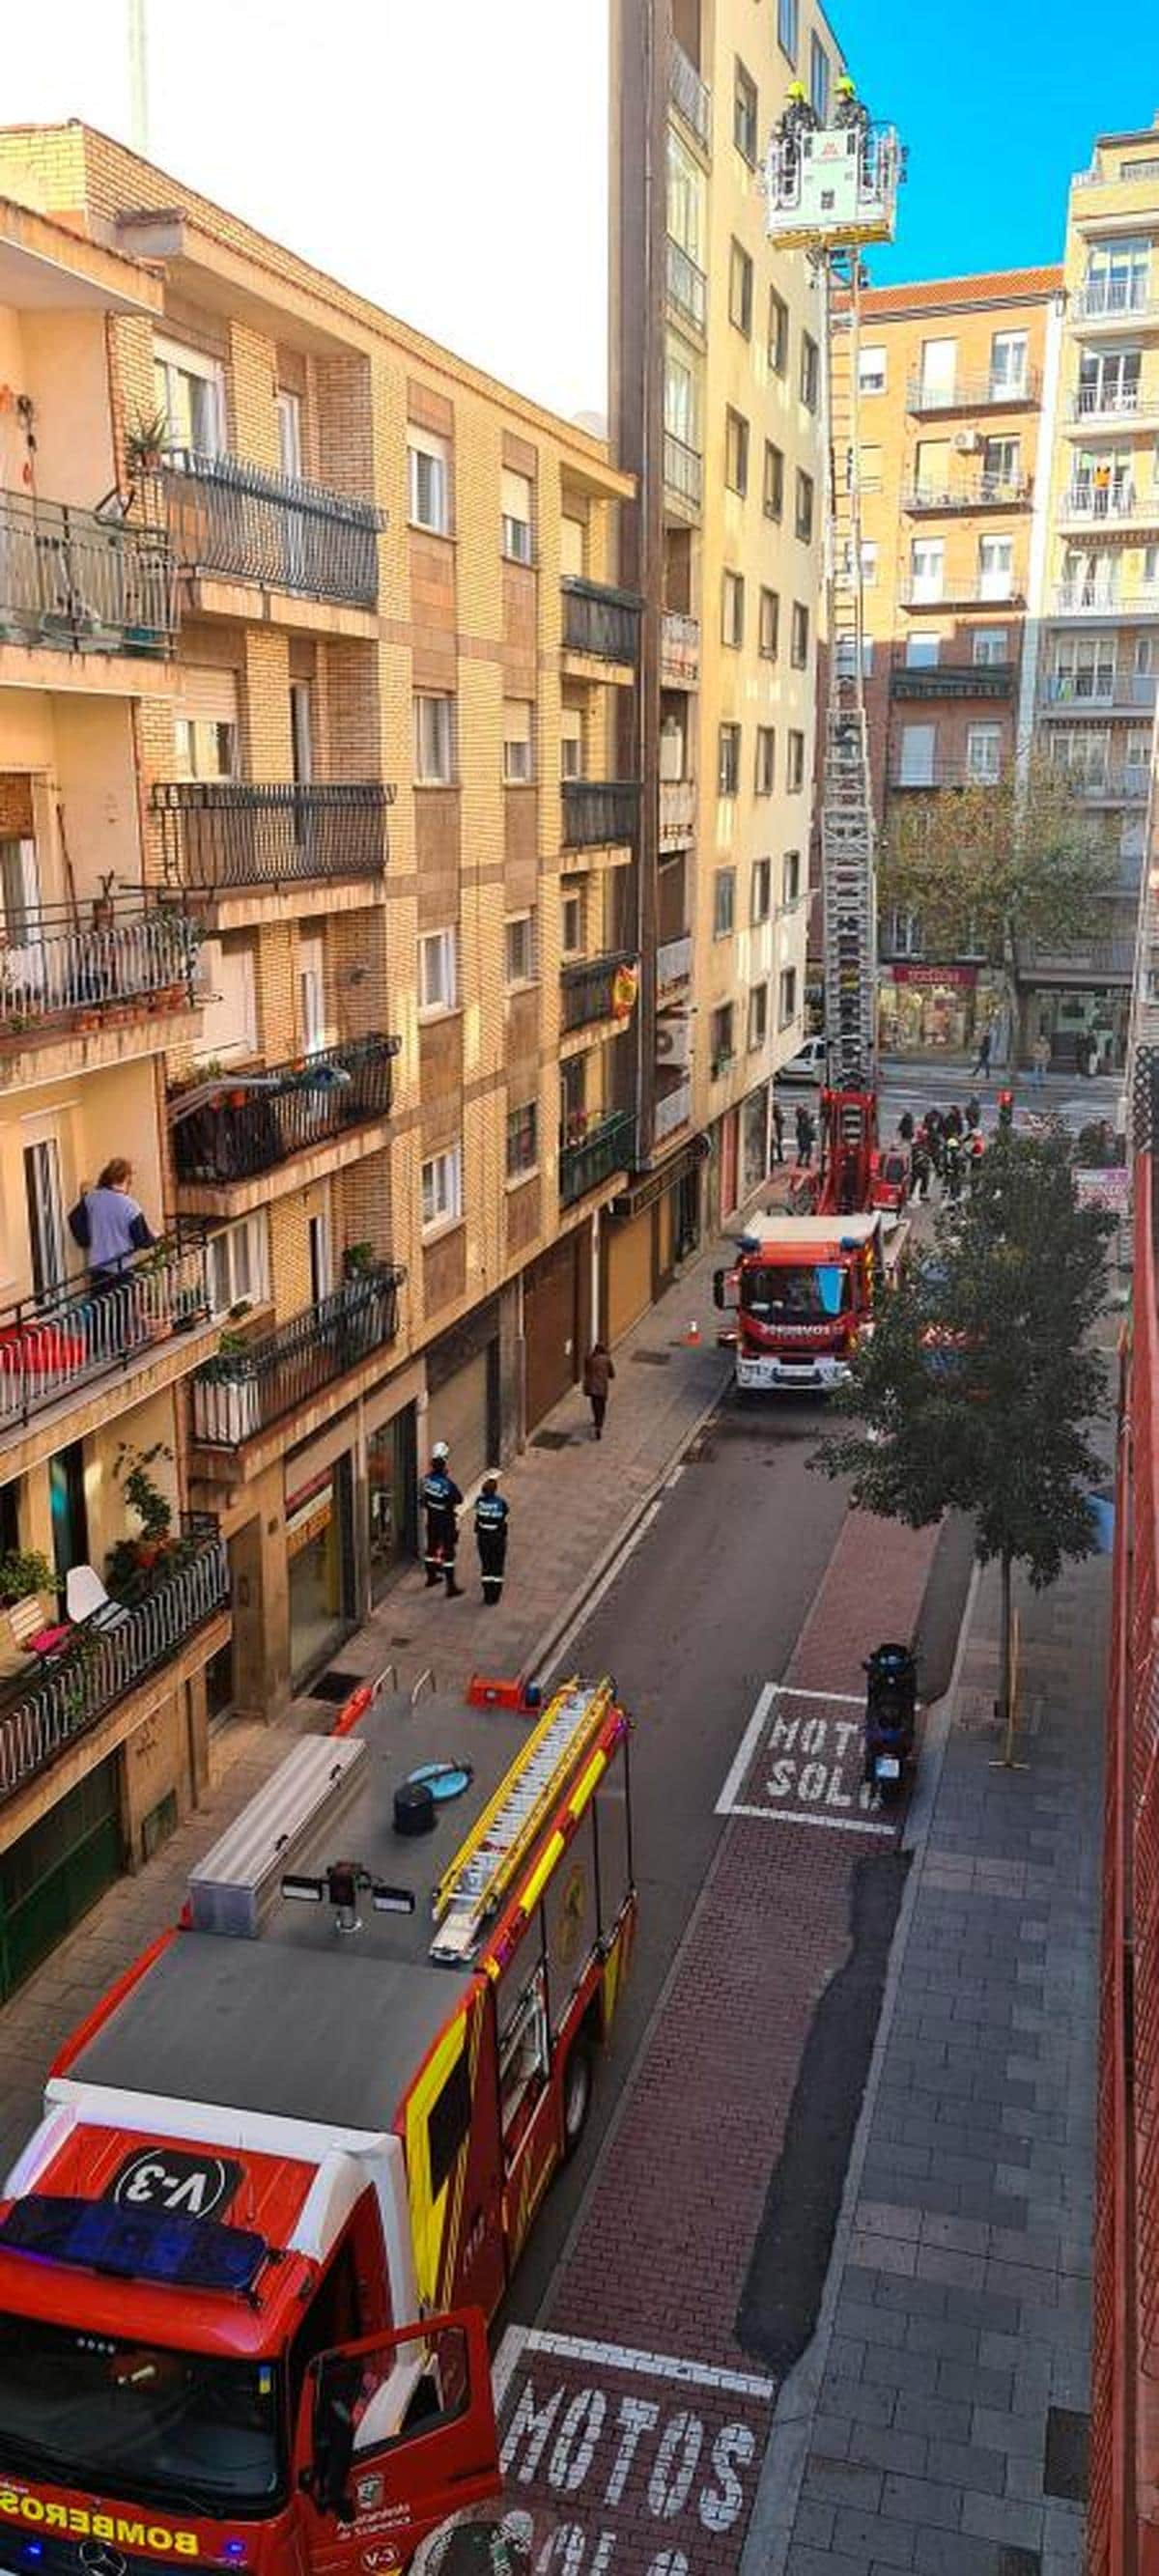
[0,2316,283,2514]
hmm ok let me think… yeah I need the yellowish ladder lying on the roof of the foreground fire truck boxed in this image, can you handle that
[430,1680,613,1968]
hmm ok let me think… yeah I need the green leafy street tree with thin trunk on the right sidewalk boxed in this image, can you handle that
[814,1128,1113,1726]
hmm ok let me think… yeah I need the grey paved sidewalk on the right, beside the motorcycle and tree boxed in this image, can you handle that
[745,1559,1108,2576]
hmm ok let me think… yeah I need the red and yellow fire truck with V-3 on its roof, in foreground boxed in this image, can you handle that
[0,1680,636,2576]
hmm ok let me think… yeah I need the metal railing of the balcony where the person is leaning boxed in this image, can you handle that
[0,1229,209,1432]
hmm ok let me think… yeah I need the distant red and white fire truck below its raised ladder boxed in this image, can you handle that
[714,1208,909,1394]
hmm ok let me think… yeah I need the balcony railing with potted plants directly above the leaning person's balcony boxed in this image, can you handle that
[0,896,198,1043]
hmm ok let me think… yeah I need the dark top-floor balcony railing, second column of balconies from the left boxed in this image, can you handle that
[162,448,386,608]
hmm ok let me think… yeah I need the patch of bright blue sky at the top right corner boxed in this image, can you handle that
[830,0,1159,286]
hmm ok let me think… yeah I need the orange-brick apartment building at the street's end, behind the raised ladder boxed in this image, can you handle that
[858,268,1061,1048]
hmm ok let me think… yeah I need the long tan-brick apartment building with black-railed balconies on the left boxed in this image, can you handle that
[0,124,638,1981]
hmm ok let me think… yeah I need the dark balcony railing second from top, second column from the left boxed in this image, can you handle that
[150,778,394,893]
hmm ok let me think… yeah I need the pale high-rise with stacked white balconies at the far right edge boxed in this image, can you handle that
[1025,124,1159,1069]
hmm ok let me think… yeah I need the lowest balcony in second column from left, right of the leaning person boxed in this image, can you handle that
[190,1262,407,1451]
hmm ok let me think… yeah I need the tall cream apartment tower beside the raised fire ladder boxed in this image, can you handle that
[610,0,842,1298]
